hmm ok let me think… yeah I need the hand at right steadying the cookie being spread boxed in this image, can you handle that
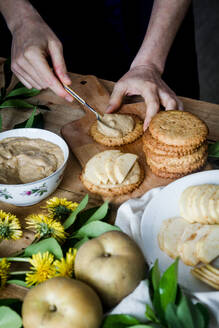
[106,65,183,131]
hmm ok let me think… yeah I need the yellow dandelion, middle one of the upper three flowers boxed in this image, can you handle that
[26,214,67,242]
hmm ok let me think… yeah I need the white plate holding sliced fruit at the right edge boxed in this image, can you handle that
[141,170,219,292]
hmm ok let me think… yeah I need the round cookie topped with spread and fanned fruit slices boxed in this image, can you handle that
[81,150,144,196]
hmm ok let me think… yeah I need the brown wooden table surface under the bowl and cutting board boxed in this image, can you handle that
[0,59,219,299]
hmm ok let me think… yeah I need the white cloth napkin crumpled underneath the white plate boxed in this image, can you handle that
[110,187,219,328]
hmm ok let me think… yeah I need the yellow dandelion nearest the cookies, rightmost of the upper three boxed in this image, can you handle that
[44,197,78,220]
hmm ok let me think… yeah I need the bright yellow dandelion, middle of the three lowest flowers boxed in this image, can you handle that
[25,252,56,287]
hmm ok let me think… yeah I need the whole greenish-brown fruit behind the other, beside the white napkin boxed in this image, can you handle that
[75,231,146,307]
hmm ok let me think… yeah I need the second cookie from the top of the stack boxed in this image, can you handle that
[142,129,197,156]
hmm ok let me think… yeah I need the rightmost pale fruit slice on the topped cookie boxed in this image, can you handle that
[114,153,138,184]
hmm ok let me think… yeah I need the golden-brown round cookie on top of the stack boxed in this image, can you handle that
[149,110,208,147]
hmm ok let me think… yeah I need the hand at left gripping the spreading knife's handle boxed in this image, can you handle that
[11,15,73,101]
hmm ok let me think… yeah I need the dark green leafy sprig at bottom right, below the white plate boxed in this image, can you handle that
[102,259,209,328]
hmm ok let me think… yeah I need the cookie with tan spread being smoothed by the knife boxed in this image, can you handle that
[90,114,143,146]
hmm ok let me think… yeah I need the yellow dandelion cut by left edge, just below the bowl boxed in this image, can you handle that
[0,210,22,241]
